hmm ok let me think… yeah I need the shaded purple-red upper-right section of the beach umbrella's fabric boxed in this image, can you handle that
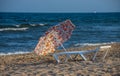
[45,20,75,47]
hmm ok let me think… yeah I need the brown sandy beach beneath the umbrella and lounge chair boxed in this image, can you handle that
[0,43,120,76]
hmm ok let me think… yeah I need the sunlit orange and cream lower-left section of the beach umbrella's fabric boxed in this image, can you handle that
[34,33,55,55]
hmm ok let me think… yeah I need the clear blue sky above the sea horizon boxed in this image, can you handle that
[0,0,120,12]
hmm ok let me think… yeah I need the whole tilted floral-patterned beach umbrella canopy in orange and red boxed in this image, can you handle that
[34,20,75,55]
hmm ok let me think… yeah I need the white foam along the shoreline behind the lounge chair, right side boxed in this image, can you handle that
[74,42,116,46]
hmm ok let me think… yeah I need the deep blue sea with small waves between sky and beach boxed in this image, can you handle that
[0,12,120,55]
